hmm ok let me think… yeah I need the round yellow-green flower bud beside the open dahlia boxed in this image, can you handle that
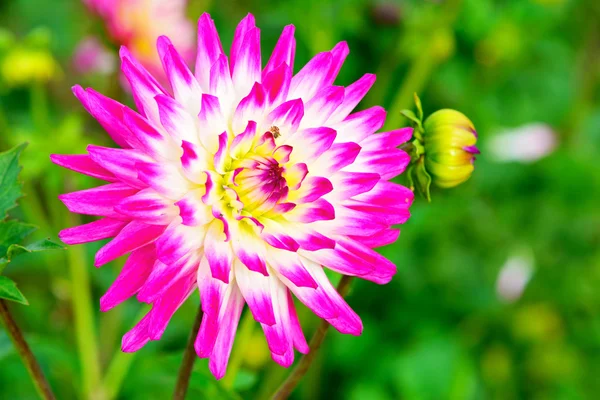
[423,109,479,188]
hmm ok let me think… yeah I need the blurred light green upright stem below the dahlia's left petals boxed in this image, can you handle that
[67,214,104,400]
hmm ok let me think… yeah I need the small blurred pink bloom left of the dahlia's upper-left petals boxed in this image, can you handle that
[72,37,117,75]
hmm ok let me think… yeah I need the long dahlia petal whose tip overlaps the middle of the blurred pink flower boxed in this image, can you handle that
[157,36,202,115]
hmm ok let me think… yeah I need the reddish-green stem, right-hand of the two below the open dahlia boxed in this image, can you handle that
[271,275,352,400]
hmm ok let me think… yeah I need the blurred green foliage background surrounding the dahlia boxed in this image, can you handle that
[0,0,600,400]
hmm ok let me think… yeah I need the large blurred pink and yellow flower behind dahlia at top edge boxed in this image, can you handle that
[84,0,195,81]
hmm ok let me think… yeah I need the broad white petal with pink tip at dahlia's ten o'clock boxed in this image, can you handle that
[155,95,200,144]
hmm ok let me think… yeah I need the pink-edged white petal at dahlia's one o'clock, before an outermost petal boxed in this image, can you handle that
[288,52,333,102]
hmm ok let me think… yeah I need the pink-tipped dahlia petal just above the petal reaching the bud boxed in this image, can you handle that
[331,106,386,143]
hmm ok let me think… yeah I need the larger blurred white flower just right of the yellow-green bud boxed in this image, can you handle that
[486,123,557,163]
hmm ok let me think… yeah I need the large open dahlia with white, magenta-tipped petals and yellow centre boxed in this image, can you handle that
[52,14,413,378]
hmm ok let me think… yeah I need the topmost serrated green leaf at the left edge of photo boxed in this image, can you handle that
[0,143,27,221]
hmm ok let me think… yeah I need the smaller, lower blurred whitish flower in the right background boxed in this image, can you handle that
[496,253,534,303]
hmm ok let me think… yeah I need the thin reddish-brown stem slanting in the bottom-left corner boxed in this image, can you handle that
[0,300,56,400]
